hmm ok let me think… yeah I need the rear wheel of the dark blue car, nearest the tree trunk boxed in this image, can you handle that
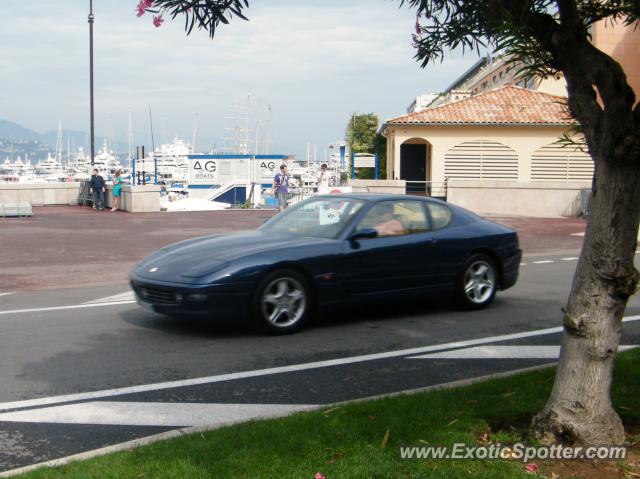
[456,253,498,310]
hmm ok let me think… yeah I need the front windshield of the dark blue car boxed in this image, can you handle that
[261,196,365,239]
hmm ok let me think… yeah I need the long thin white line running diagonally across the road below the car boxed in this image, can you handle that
[0,315,640,412]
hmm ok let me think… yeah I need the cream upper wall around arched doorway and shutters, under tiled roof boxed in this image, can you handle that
[387,125,568,183]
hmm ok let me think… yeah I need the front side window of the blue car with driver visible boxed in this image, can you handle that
[356,201,429,237]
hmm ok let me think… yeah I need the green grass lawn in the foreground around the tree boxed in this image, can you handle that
[15,350,640,479]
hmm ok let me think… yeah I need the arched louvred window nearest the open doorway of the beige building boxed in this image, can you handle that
[444,140,518,180]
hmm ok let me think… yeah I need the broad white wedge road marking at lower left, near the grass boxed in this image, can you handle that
[0,401,319,427]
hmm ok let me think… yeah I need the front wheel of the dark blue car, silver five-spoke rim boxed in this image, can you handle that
[252,269,312,334]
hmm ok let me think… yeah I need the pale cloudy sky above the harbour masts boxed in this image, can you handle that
[0,0,477,160]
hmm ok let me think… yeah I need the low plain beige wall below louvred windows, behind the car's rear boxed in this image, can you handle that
[447,181,591,217]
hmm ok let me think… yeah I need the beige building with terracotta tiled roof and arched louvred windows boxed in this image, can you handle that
[382,85,593,216]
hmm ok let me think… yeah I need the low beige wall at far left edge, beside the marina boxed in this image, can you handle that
[0,182,80,206]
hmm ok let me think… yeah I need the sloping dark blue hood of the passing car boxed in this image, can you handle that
[135,230,326,283]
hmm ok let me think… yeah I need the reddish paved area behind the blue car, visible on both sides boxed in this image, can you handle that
[0,206,584,292]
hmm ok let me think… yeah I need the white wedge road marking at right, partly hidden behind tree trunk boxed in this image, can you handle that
[408,344,638,360]
